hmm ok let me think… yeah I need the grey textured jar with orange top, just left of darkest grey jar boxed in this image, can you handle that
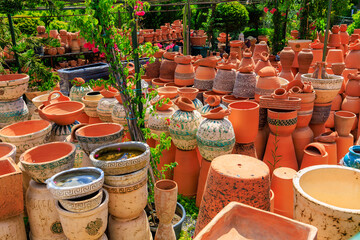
[212,63,236,94]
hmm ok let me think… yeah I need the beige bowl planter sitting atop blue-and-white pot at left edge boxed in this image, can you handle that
[0,74,29,102]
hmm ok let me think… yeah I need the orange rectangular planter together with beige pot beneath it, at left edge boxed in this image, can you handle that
[0,158,27,240]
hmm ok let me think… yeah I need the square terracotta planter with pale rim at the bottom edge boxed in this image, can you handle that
[194,202,317,240]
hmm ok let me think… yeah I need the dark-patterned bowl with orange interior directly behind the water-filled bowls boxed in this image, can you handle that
[75,123,124,155]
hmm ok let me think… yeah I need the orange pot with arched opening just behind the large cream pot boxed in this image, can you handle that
[300,142,329,169]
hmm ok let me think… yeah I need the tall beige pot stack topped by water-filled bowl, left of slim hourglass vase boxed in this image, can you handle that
[90,141,152,240]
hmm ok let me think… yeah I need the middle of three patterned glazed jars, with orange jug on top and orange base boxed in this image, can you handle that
[169,97,201,196]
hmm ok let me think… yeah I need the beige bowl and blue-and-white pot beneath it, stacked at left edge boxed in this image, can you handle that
[0,74,29,128]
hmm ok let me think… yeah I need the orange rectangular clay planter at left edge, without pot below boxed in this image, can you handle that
[0,158,24,220]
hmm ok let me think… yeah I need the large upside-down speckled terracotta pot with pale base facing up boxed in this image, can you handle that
[195,154,270,234]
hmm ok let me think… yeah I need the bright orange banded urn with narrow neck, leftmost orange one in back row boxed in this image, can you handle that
[175,55,195,86]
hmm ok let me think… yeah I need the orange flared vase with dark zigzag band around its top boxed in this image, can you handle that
[263,109,298,173]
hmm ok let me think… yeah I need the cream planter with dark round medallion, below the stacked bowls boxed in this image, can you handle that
[56,190,109,240]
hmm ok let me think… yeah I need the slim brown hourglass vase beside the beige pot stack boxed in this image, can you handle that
[154,180,178,240]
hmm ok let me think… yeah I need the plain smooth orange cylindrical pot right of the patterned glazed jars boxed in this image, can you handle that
[229,101,259,143]
